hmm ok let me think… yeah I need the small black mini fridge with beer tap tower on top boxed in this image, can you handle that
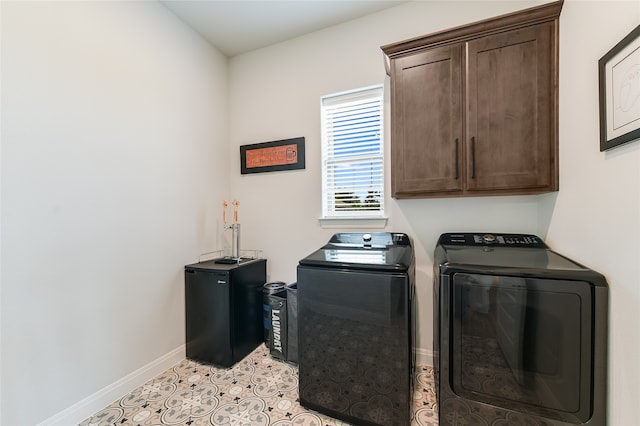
[185,259,267,367]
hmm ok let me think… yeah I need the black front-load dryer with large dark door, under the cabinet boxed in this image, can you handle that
[433,233,608,426]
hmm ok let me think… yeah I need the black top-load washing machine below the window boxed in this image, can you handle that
[298,232,415,426]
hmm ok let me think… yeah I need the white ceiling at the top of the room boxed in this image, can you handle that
[161,0,407,57]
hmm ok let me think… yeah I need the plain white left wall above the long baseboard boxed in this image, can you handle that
[0,1,230,425]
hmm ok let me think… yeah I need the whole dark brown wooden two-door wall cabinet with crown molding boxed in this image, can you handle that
[382,1,562,198]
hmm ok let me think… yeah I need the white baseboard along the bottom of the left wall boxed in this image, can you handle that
[38,345,185,426]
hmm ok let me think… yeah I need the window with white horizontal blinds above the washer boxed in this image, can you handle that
[321,86,384,218]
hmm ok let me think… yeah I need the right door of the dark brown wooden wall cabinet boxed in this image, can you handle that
[466,23,557,193]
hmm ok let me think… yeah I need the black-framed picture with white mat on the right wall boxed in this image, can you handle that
[598,25,640,151]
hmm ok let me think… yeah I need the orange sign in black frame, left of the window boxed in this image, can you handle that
[240,138,305,175]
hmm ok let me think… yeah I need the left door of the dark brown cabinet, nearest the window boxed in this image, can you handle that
[391,44,463,198]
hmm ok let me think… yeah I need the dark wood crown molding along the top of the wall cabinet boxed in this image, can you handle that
[380,0,564,62]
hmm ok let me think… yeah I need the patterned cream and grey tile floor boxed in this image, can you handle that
[80,345,438,426]
